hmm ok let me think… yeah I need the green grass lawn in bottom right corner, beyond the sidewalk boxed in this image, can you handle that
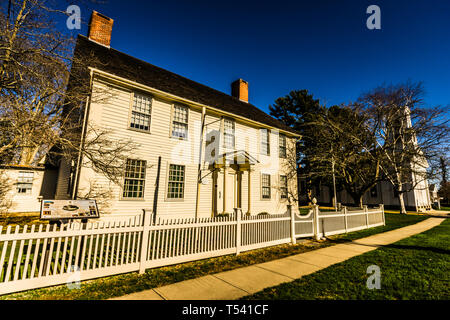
[243,219,450,300]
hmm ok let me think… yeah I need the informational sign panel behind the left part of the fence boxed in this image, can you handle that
[41,200,100,220]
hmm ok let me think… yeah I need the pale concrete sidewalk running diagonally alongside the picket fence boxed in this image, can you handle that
[111,218,444,300]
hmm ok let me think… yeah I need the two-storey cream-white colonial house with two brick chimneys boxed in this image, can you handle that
[50,12,299,218]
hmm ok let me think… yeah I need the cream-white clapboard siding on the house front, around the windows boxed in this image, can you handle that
[67,81,296,217]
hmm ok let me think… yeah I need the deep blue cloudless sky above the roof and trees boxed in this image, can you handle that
[64,0,450,112]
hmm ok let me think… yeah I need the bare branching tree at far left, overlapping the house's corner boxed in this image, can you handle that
[0,0,136,198]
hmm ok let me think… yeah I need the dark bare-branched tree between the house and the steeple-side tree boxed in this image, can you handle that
[309,104,381,207]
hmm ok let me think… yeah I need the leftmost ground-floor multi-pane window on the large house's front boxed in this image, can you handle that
[123,159,147,198]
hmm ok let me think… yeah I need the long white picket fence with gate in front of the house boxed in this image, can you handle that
[0,206,384,295]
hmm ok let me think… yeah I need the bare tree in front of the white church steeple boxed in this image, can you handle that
[355,82,449,213]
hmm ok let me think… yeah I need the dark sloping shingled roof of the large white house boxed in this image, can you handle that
[74,35,298,135]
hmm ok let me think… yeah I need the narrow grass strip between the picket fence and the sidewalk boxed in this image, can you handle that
[0,213,426,300]
